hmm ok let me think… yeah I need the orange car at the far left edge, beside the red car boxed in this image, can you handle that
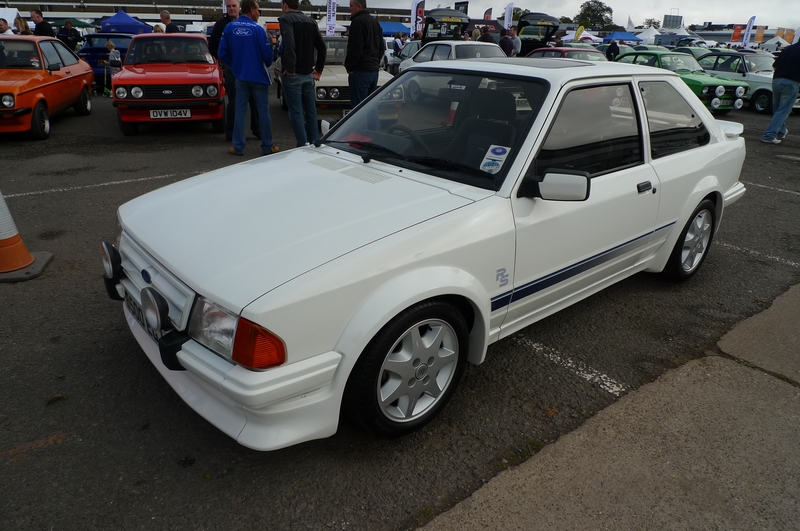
[0,35,94,140]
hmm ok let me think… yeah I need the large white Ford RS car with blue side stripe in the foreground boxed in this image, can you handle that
[102,58,745,450]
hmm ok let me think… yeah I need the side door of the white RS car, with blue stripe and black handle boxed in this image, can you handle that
[501,81,660,336]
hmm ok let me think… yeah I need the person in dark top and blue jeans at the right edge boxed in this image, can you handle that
[761,43,800,144]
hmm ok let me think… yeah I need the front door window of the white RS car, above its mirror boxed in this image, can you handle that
[529,84,644,177]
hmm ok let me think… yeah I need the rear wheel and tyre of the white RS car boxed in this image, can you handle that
[663,199,716,280]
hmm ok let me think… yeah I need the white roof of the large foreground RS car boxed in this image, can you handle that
[406,57,678,84]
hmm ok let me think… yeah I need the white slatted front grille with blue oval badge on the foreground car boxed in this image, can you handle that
[119,232,195,330]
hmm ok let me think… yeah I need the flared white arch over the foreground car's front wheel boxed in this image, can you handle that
[335,266,491,364]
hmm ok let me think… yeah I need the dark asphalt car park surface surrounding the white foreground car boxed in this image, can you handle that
[0,84,800,530]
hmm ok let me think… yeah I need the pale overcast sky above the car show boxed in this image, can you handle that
[356,0,800,29]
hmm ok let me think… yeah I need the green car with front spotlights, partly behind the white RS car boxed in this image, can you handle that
[617,51,750,114]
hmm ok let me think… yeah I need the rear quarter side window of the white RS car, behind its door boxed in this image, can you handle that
[639,81,711,159]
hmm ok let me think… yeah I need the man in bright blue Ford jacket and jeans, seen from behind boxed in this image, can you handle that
[219,0,279,156]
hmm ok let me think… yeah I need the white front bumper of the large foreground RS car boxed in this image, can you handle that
[124,307,344,450]
